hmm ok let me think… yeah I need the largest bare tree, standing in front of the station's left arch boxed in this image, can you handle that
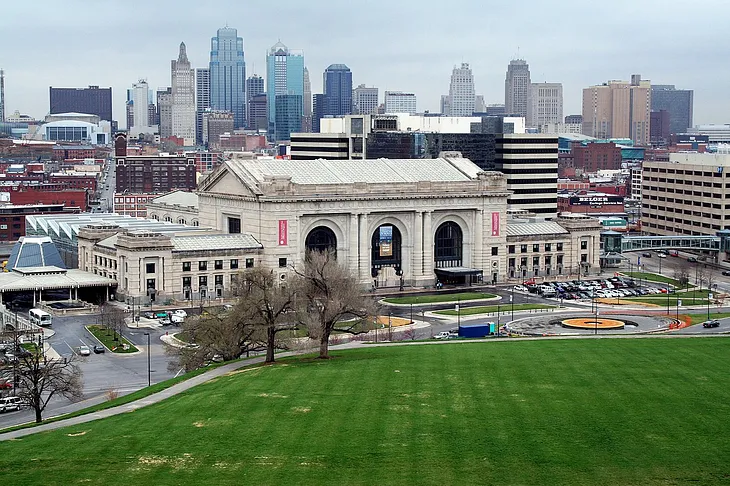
[296,251,374,359]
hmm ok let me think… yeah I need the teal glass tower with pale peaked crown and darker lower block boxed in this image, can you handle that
[266,41,304,141]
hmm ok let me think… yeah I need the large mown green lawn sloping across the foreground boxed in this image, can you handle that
[0,338,730,486]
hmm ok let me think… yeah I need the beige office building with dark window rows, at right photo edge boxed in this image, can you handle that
[641,153,730,236]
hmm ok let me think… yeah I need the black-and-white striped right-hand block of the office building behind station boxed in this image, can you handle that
[495,134,558,218]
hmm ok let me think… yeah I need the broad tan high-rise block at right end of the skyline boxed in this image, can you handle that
[583,74,651,145]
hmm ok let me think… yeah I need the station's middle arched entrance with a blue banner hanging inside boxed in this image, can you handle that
[370,224,403,287]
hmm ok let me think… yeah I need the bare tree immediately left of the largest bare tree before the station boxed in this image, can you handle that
[233,267,297,363]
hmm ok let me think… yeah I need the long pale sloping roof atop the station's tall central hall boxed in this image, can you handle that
[232,158,481,184]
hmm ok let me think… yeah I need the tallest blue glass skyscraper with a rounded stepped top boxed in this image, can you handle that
[210,27,246,128]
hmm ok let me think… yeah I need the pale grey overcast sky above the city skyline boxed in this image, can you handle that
[0,0,730,126]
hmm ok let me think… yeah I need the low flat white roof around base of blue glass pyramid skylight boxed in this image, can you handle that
[0,267,117,293]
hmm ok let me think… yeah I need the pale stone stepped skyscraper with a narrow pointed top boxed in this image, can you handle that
[169,42,196,145]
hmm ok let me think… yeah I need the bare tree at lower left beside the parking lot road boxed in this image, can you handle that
[14,349,83,423]
